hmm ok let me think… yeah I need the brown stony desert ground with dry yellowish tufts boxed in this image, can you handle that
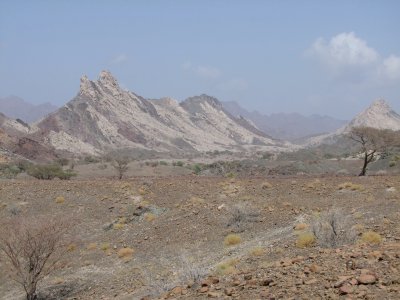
[0,172,400,300]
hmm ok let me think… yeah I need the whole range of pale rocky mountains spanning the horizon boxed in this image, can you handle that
[0,71,400,159]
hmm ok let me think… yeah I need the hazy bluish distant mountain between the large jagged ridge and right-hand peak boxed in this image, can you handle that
[222,101,347,141]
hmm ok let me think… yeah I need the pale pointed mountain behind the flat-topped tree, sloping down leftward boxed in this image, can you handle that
[304,99,400,146]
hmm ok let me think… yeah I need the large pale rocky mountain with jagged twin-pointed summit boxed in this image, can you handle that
[35,71,290,154]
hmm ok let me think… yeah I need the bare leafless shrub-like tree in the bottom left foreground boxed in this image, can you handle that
[0,216,72,300]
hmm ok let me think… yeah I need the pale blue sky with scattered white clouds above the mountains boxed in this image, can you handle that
[0,0,400,119]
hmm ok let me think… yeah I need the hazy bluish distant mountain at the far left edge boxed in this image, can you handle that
[0,96,57,123]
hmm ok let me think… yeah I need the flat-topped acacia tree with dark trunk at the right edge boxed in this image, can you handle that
[348,127,398,176]
